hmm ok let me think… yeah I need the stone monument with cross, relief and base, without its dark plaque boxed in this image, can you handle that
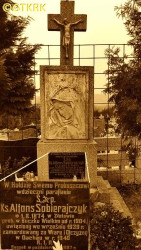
[37,1,97,186]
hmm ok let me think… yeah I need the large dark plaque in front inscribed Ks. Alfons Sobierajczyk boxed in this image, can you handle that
[0,181,89,250]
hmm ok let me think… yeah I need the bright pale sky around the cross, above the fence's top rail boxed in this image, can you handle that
[14,0,128,45]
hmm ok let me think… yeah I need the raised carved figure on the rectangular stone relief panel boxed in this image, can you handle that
[49,87,85,139]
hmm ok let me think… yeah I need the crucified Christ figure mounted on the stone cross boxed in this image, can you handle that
[54,18,83,58]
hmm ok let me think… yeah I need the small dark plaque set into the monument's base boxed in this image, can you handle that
[48,152,85,179]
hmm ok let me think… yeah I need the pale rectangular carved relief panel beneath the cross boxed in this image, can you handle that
[45,71,88,139]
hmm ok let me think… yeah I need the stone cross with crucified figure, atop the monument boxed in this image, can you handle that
[48,0,87,66]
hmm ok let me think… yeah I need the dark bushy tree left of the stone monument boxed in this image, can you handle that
[0,0,39,115]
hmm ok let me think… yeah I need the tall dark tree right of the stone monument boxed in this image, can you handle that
[105,0,141,138]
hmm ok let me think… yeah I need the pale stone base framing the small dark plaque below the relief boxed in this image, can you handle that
[37,140,97,187]
